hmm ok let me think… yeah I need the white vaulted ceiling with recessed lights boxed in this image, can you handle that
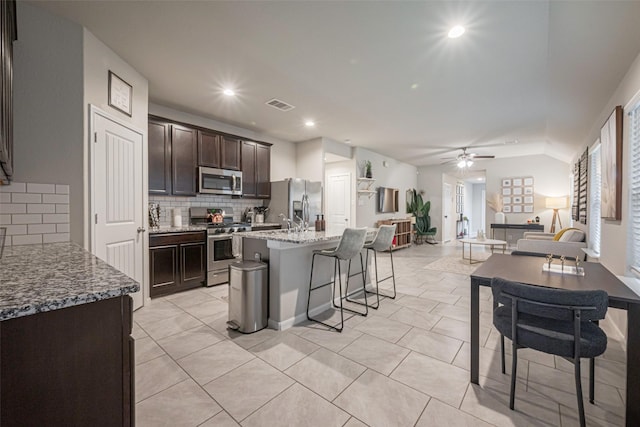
[31,0,640,165]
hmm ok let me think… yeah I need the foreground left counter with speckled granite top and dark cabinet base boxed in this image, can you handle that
[0,243,140,426]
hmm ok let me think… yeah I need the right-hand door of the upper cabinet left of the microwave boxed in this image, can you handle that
[171,124,198,196]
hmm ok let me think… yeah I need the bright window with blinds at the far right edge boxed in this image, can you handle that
[628,103,640,274]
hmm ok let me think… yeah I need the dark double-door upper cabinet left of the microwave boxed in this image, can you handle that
[148,117,198,196]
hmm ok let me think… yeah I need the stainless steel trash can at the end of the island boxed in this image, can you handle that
[227,261,269,334]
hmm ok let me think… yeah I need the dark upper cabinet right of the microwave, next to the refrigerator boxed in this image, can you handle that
[242,141,271,199]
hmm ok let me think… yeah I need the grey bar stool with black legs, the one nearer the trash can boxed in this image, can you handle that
[307,228,369,332]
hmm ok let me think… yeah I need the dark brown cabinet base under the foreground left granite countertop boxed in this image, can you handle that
[0,295,135,427]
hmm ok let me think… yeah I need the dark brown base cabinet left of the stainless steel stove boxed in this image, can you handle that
[149,231,207,298]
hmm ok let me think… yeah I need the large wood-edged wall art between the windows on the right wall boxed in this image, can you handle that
[600,105,623,220]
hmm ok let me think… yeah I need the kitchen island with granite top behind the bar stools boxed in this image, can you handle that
[236,229,375,330]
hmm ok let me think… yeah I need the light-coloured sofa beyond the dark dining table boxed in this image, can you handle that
[514,228,587,259]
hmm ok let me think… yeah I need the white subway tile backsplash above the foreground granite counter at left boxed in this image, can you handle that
[0,182,69,246]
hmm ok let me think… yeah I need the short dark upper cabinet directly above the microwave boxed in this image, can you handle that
[198,130,241,170]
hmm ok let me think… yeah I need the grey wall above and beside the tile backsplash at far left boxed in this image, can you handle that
[13,2,85,244]
